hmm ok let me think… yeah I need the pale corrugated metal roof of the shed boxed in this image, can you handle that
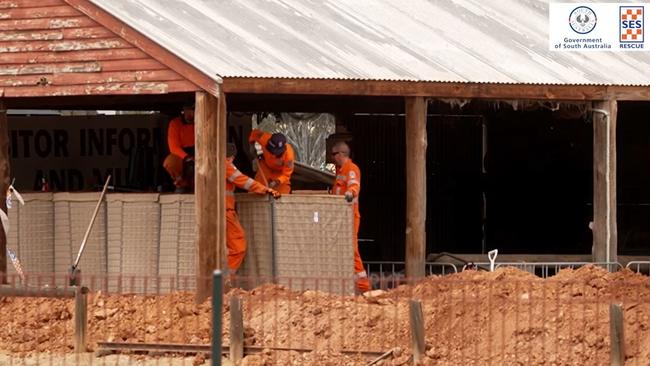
[90,0,650,85]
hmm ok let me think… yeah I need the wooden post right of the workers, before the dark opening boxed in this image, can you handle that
[406,97,427,279]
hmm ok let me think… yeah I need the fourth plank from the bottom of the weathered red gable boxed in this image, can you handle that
[0,48,146,63]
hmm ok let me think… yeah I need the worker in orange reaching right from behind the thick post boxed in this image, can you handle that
[226,143,280,275]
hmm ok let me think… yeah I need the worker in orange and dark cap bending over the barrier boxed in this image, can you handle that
[248,129,294,194]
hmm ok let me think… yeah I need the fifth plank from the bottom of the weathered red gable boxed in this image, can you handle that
[0,38,132,53]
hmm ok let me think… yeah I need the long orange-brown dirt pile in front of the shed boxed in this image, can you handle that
[0,266,650,366]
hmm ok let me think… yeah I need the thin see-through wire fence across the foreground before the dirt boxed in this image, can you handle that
[0,265,650,366]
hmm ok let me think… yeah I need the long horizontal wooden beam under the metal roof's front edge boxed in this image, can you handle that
[222,78,650,101]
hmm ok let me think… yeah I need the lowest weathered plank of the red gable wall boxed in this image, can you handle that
[4,80,199,98]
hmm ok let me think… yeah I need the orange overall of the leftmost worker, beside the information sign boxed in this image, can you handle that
[163,117,194,188]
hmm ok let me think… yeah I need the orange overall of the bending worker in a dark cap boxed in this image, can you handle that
[248,129,295,194]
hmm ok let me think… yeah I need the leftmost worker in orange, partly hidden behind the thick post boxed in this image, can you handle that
[163,103,194,193]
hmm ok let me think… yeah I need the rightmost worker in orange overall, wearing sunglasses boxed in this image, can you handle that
[332,141,370,293]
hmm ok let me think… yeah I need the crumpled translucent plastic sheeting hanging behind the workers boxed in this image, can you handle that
[253,113,336,170]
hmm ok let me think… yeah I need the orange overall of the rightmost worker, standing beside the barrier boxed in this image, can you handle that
[332,159,370,292]
